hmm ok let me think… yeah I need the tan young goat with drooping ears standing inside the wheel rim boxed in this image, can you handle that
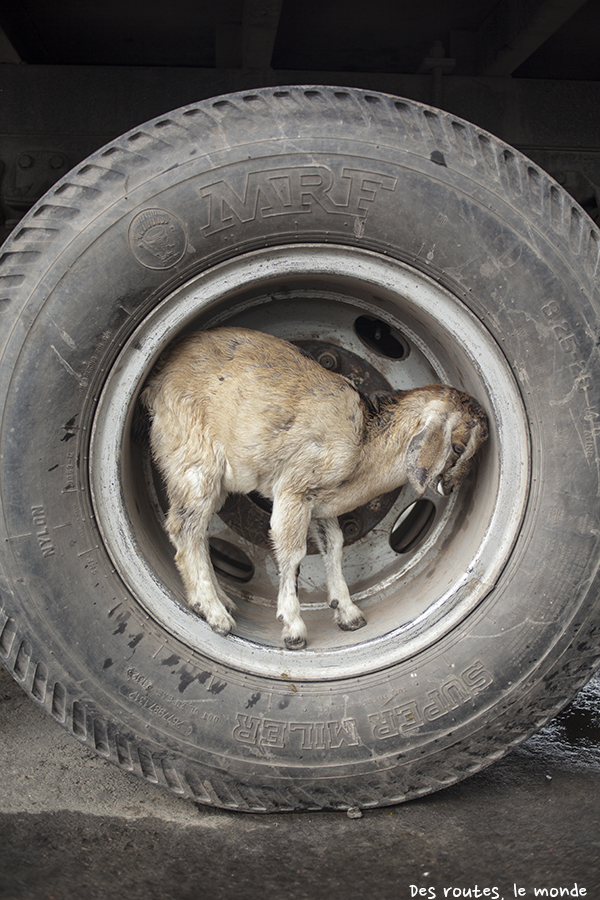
[142,328,488,650]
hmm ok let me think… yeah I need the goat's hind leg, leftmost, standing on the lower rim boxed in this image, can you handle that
[166,471,235,636]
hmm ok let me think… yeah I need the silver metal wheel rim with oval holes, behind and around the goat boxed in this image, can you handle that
[90,244,529,681]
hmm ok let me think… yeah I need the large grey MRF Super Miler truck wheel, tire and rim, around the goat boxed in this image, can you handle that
[0,87,600,812]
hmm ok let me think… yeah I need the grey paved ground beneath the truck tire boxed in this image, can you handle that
[0,669,600,900]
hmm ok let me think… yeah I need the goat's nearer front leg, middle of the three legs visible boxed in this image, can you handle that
[271,493,310,650]
